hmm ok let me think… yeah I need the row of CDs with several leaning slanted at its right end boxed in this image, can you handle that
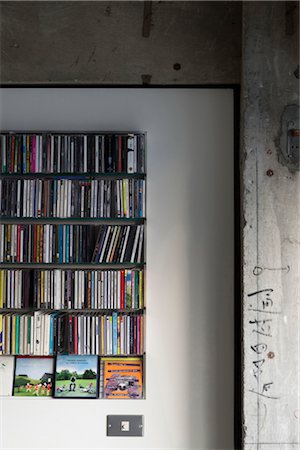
[0,224,144,263]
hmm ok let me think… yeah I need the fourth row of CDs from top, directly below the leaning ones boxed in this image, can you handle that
[0,269,144,310]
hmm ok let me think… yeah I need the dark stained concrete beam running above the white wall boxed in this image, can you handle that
[0,1,241,84]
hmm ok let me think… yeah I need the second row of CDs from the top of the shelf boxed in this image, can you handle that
[0,178,145,218]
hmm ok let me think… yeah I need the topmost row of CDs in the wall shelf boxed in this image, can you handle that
[0,133,145,174]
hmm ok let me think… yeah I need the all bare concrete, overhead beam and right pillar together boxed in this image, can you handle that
[0,1,300,450]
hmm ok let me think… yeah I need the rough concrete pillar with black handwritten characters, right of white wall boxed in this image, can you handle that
[241,2,300,450]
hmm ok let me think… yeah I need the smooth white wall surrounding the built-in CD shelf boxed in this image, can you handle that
[0,89,234,450]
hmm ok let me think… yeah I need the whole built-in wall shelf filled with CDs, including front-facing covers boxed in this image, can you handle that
[0,130,147,399]
